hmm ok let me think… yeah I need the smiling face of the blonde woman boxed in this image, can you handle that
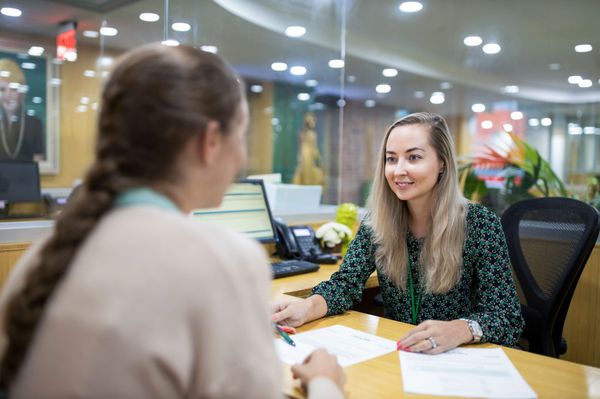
[385,125,444,208]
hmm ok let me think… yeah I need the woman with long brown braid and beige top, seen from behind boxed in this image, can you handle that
[0,45,344,398]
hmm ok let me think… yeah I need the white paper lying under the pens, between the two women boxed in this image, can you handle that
[275,326,396,367]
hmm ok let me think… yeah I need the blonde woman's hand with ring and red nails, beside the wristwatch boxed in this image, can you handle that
[397,320,473,355]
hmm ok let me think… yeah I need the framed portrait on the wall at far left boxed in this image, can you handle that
[0,47,59,174]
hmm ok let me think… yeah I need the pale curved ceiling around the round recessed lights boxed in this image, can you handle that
[0,0,600,113]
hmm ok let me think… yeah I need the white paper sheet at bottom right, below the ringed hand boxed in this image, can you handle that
[398,348,537,398]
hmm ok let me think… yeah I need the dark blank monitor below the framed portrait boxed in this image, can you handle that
[0,161,41,203]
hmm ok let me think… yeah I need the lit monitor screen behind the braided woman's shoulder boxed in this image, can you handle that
[191,180,276,243]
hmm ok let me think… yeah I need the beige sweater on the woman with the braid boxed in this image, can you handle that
[0,206,341,399]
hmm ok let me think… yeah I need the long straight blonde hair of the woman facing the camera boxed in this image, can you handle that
[367,112,467,294]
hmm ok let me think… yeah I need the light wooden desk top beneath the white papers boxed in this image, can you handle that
[286,311,600,398]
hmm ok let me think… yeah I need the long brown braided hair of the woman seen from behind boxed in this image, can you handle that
[0,44,244,389]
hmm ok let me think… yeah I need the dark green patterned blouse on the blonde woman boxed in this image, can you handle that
[312,204,524,346]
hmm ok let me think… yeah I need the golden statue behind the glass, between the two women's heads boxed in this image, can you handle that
[292,112,325,185]
